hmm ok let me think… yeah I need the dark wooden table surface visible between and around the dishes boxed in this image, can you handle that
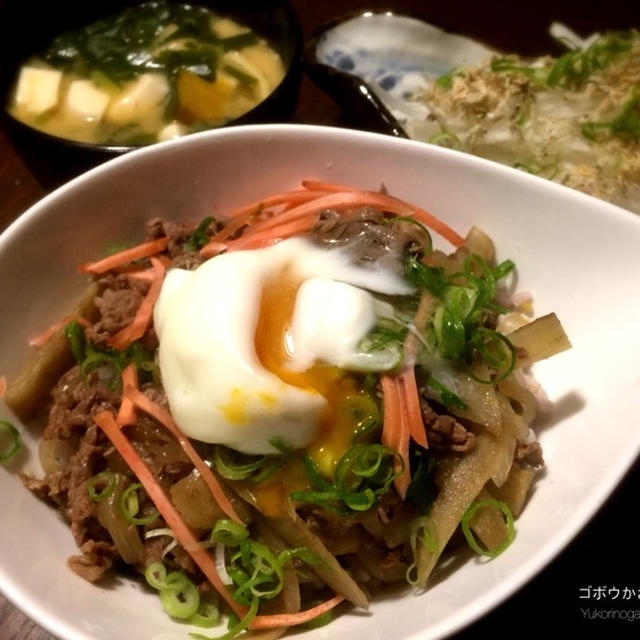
[0,0,640,640]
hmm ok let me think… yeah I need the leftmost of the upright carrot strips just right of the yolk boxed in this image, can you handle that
[380,374,411,500]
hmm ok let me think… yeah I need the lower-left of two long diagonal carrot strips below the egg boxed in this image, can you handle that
[94,411,247,618]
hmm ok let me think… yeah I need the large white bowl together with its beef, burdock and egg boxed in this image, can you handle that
[0,125,640,639]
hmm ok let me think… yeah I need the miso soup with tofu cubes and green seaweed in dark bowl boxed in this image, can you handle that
[8,2,285,146]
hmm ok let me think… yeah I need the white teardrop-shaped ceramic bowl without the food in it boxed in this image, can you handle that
[0,125,640,640]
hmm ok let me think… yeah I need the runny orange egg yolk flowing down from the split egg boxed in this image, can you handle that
[255,267,361,477]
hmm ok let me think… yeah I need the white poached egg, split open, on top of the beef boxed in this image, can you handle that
[154,238,412,454]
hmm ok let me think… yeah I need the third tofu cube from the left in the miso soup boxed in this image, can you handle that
[106,73,169,125]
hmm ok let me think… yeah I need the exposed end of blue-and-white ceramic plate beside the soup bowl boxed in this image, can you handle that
[305,12,494,139]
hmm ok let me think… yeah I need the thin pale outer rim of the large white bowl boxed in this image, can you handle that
[0,124,640,640]
